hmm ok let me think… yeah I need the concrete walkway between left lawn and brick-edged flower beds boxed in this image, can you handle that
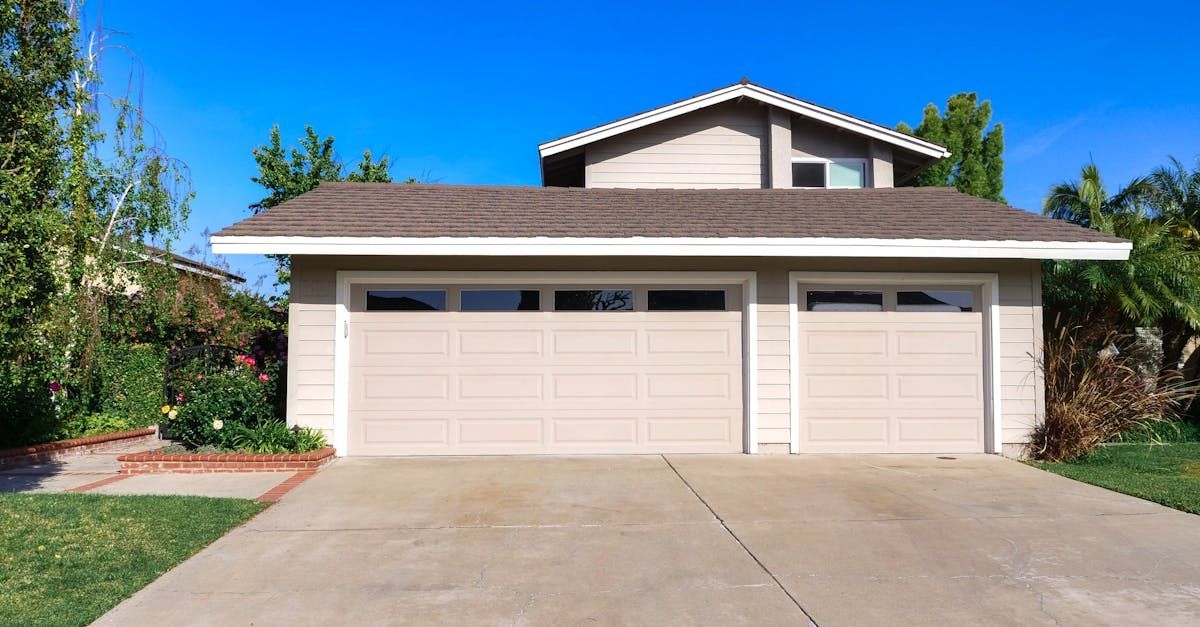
[0,444,294,498]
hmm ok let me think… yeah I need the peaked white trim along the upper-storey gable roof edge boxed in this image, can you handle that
[538,84,950,159]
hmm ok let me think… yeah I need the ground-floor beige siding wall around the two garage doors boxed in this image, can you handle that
[288,256,1044,454]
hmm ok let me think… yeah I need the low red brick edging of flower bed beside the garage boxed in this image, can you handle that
[116,447,334,474]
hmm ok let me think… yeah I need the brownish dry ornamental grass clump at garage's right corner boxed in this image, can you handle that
[1030,327,1194,461]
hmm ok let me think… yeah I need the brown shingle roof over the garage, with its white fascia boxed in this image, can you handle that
[212,183,1129,258]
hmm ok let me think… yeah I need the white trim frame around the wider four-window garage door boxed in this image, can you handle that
[332,270,758,456]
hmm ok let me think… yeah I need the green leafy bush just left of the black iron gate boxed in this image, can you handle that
[98,344,166,429]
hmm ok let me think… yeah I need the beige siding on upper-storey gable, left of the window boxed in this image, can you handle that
[584,102,768,189]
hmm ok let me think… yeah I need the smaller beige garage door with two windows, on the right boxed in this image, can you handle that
[796,285,984,453]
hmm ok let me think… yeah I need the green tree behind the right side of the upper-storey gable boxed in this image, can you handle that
[896,92,1004,202]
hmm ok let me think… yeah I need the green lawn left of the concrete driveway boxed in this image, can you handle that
[0,494,265,626]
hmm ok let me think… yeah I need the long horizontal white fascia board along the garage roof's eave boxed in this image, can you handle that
[211,235,1132,259]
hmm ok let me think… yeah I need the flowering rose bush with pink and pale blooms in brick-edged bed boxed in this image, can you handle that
[169,359,274,448]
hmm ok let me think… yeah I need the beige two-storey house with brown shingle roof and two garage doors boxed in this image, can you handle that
[212,82,1130,455]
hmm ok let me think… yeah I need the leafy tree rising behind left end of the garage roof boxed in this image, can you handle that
[250,125,391,289]
